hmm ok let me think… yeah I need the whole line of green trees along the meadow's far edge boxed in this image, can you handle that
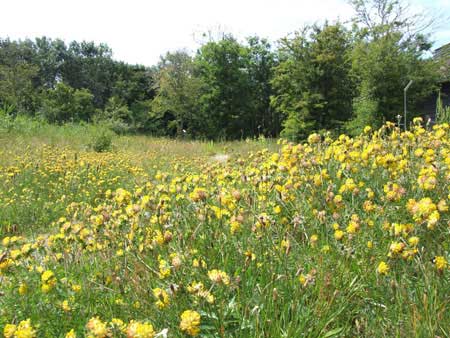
[0,0,441,140]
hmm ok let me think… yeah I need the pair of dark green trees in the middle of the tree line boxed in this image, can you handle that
[195,35,280,139]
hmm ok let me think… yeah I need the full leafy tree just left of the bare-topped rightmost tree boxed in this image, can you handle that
[271,23,354,139]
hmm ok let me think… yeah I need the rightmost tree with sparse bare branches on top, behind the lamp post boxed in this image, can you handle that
[348,0,438,134]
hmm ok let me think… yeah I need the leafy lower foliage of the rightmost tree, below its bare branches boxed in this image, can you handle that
[353,33,436,131]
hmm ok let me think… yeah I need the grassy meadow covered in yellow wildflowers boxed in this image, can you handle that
[0,117,450,338]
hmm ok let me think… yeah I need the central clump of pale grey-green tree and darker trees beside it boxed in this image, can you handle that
[150,35,280,139]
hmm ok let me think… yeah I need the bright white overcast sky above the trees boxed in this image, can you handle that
[0,0,450,66]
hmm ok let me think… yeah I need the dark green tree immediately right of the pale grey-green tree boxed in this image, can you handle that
[195,35,257,138]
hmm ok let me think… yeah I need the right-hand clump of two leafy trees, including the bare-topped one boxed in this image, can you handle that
[271,0,439,140]
